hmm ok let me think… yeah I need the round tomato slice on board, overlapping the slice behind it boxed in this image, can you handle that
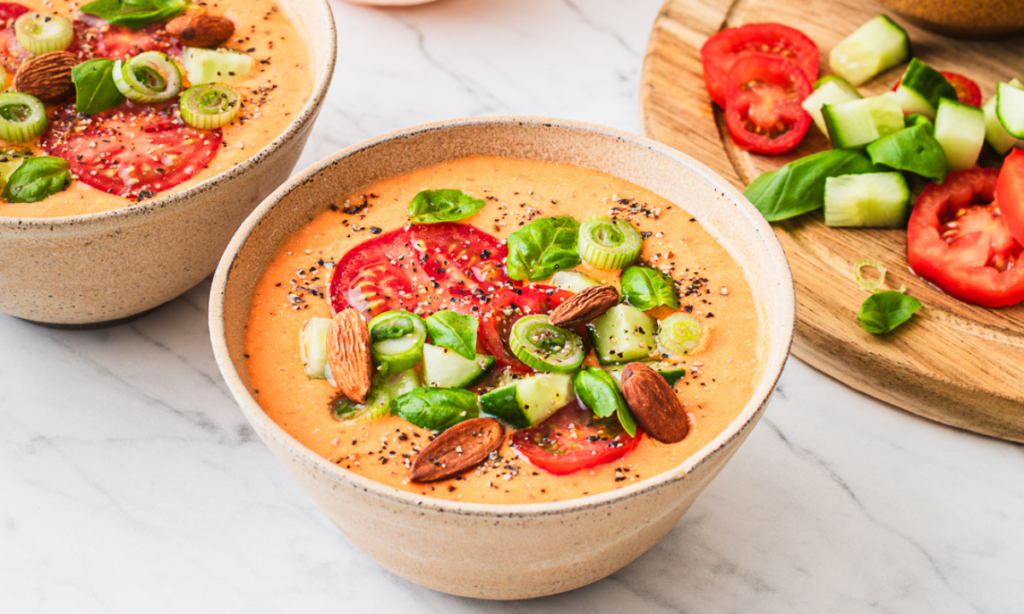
[725,55,811,155]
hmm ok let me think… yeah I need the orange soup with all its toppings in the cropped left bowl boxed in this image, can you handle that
[0,0,313,217]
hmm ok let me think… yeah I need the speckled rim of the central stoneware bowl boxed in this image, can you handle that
[209,116,796,518]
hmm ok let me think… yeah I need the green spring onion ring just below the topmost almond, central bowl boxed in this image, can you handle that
[509,315,585,374]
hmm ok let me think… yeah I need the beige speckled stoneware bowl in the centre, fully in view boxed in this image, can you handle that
[210,118,794,599]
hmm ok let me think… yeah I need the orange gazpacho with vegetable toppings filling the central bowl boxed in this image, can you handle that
[245,157,762,503]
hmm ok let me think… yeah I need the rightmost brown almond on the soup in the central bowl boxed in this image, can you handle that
[622,362,690,443]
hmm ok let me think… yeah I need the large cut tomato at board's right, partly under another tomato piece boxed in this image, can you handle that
[907,168,1024,307]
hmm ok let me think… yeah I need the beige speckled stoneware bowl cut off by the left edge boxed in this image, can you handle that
[0,0,337,327]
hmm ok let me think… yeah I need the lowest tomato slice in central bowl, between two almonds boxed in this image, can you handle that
[512,401,643,476]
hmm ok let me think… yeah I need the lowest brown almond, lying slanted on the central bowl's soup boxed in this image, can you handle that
[411,418,505,482]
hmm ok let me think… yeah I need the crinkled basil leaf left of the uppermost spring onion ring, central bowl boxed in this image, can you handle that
[508,216,580,281]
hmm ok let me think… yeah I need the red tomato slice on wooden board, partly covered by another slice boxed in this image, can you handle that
[700,24,818,108]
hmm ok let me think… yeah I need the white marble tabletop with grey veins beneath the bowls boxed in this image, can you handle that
[0,0,1024,614]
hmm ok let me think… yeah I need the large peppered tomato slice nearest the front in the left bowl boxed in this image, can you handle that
[40,101,222,201]
